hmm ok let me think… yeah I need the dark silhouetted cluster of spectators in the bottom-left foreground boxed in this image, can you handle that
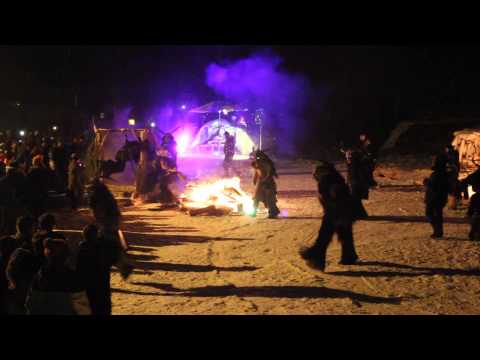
[0,180,133,315]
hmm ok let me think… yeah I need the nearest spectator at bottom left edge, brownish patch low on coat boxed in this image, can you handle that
[25,238,92,315]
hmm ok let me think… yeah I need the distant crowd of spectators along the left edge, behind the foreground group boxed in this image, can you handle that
[0,131,86,235]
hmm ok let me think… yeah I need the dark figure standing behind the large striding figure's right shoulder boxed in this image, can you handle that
[345,150,371,219]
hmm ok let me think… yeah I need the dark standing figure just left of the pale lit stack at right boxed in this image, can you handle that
[423,154,449,238]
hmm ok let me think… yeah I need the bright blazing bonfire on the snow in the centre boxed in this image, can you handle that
[180,177,254,216]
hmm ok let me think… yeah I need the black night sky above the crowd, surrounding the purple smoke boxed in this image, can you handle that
[0,45,480,154]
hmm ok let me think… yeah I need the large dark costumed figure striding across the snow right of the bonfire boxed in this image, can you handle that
[300,162,358,271]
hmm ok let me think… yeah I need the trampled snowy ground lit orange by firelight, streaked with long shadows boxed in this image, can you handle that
[54,157,480,314]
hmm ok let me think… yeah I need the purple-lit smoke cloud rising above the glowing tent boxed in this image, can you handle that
[206,53,310,154]
